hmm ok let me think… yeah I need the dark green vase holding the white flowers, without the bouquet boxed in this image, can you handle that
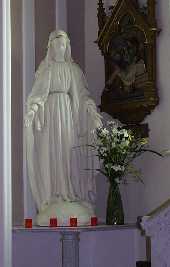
[106,180,124,225]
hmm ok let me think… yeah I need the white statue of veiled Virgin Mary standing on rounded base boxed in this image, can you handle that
[25,31,101,225]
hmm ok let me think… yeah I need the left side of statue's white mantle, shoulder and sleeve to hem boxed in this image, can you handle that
[24,60,51,209]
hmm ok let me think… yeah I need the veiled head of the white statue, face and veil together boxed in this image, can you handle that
[48,30,72,62]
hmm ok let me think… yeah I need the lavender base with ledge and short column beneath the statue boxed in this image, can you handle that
[12,225,145,267]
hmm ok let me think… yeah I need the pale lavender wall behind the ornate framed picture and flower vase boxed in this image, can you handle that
[85,0,170,222]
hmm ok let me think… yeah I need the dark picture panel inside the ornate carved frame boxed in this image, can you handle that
[105,29,148,101]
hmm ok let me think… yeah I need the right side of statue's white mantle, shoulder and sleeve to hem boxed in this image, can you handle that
[70,63,102,203]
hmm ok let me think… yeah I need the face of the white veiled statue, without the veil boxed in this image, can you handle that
[51,36,66,57]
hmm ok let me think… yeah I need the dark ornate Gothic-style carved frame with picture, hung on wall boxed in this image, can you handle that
[97,0,159,136]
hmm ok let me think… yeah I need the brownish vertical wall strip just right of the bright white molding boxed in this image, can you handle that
[11,0,23,227]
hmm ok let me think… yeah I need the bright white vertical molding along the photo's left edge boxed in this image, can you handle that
[0,0,12,267]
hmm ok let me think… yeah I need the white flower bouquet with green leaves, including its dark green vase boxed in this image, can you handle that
[93,121,162,225]
